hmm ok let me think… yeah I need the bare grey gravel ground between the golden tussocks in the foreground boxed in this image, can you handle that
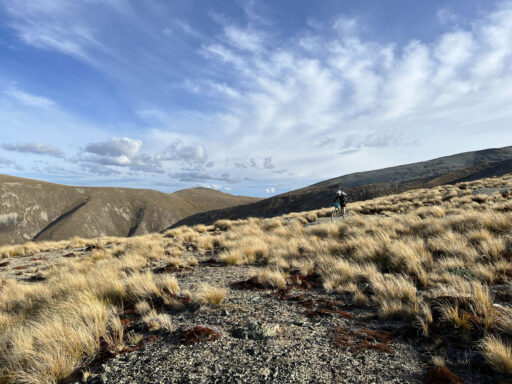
[80,258,425,384]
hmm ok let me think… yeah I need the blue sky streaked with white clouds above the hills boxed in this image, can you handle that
[0,0,512,197]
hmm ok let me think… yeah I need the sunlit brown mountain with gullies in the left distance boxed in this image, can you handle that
[0,175,259,245]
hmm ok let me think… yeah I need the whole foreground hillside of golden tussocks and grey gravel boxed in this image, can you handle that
[0,174,512,384]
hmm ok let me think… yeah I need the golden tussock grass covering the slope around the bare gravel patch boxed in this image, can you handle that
[0,176,512,383]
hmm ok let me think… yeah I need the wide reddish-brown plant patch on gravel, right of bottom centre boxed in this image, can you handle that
[332,327,391,354]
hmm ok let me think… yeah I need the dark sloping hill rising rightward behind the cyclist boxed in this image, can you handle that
[173,147,512,227]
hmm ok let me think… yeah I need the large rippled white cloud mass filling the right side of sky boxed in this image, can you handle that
[184,2,512,190]
